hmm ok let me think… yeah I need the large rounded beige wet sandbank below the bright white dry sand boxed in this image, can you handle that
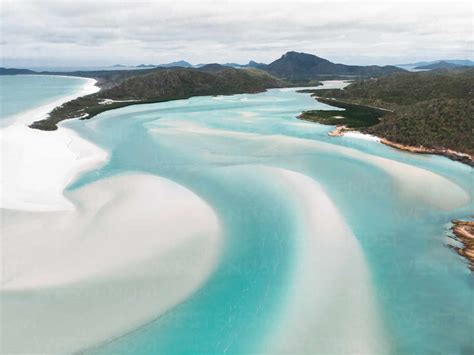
[1,174,220,353]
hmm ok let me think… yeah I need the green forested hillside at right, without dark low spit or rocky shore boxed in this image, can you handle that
[308,69,474,155]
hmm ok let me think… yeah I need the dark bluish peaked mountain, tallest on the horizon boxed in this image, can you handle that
[261,52,404,81]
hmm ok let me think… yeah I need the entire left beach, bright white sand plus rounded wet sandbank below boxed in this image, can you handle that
[0,79,224,353]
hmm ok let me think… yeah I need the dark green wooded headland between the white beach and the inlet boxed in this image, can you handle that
[30,64,287,130]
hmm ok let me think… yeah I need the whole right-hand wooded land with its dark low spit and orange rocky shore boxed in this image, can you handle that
[300,68,474,166]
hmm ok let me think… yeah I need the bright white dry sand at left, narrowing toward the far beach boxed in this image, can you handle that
[0,77,108,211]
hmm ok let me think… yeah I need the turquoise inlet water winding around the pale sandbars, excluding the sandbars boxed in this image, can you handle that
[61,90,474,354]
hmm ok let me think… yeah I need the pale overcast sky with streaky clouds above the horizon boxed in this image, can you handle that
[0,0,474,67]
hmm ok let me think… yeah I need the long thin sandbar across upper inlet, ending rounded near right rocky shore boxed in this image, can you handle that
[150,120,470,210]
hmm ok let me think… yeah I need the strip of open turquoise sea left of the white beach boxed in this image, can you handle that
[0,75,84,125]
